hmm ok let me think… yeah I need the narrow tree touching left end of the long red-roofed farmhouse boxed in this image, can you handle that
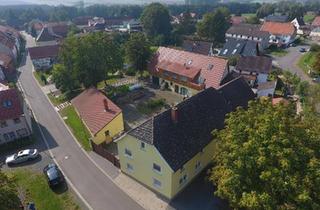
[125,33,151,75]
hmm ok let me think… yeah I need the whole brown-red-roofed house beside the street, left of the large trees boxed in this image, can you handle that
[28,45,60,70]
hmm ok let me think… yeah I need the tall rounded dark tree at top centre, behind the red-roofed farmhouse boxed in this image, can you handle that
[141,3,172,41]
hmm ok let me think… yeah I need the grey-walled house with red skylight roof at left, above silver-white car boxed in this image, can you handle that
[0,89,32,144]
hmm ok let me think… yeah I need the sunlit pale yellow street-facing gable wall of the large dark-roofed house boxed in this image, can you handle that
[117,135,173,198]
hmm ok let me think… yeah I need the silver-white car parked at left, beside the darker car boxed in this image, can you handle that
[6,149,39,165]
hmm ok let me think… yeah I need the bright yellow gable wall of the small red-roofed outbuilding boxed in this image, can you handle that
[92,112,124,144]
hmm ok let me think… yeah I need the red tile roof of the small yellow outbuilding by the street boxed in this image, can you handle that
[71,88,122,135]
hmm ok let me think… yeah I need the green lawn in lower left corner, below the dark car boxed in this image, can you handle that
[7,170,80,210]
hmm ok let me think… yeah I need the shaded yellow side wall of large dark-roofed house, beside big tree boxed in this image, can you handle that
[171,141,214,198]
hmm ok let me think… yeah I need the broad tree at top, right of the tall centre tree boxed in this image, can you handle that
[197,7,230,43]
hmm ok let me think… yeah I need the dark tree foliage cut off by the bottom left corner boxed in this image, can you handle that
[0,171,20,210]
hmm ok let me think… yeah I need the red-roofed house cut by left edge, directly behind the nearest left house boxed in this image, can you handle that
[0,52,16,81]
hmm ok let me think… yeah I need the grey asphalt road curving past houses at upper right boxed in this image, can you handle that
[274,45,312,83]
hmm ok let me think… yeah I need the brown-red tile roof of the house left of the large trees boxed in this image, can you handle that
[28,45,60,59]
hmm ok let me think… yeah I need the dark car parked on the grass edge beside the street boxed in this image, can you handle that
[43,163,64,187]
